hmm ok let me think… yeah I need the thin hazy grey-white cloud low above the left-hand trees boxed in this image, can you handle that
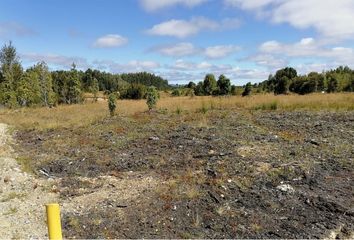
[20,53,90,69]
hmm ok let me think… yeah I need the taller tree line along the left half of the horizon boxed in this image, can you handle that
[0,42,169,108]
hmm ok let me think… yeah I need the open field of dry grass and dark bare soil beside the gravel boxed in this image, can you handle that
[0,94,354,238]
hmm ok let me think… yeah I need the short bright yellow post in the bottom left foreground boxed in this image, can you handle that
[46,203,63,240]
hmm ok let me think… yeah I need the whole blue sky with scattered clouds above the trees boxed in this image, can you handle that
[0,0,354,85]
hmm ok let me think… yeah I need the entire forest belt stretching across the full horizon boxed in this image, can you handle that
[0,42,354,108]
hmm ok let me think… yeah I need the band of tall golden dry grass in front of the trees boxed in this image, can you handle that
[0,93,354,129]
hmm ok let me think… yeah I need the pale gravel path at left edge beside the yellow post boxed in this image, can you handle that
[0,124,57,239]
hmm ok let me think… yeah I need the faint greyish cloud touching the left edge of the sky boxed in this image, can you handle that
[0,22,36,38]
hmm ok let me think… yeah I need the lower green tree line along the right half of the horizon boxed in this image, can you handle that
[176,66,354,96]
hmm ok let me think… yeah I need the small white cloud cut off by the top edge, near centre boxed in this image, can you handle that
[140,0,208,11]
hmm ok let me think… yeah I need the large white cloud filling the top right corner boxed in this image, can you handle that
[224,0,354,41]
